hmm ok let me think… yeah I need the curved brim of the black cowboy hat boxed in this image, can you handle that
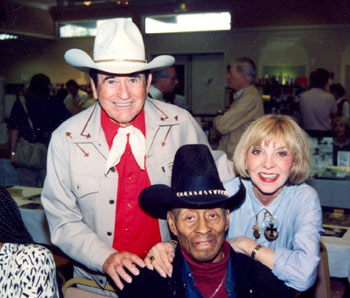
[139,183,246,219]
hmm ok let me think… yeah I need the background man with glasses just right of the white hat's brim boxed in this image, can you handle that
[148,66,187,109]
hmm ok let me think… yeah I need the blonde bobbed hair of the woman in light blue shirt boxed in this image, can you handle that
[233,115,312,184]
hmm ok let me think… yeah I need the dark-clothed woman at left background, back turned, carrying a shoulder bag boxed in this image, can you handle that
[8,73,70,187]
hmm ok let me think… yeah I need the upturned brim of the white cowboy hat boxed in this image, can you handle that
[64,49,175,74]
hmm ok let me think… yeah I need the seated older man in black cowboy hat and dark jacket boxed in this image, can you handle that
[121,145,293,298]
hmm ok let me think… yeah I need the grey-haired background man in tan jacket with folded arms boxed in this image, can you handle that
[213,57,264,159]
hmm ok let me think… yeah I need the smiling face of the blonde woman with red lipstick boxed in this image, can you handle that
[246,140,294,206]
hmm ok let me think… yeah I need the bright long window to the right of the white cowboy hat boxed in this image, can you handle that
[145,12,231,33]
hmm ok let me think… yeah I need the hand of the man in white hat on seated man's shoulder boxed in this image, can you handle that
[102,251,145,290]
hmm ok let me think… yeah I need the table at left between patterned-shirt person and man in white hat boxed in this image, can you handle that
[7,186,52,245]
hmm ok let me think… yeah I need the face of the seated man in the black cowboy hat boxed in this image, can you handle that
[168,208,230,263]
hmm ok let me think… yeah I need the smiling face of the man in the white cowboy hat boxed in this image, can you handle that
[91,73,152,127]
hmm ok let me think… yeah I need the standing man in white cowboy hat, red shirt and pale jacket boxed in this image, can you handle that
[42,19,233,289]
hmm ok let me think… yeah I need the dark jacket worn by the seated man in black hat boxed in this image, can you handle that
[119,247,293,298]
